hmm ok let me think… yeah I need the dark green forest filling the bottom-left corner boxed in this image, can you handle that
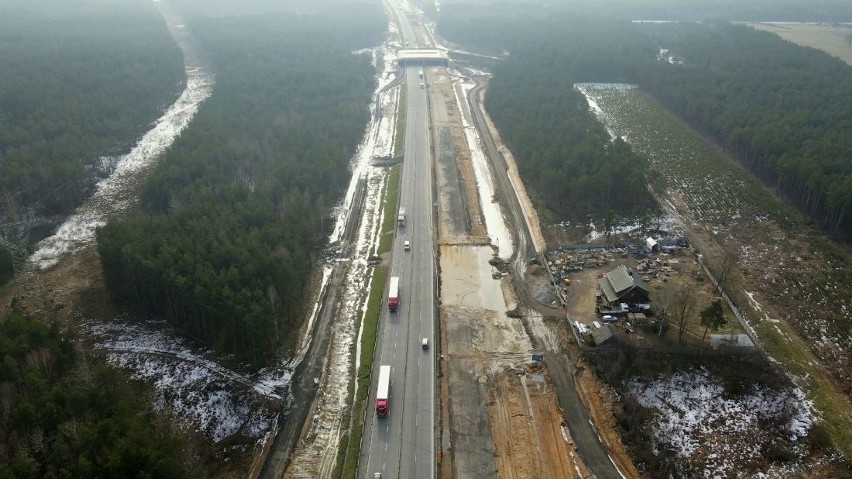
[0,311,196,479]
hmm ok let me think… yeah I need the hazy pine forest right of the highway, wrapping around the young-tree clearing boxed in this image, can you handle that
[440,6,852,237]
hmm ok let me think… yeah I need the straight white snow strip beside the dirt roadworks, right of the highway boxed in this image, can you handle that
[453,77,515,258]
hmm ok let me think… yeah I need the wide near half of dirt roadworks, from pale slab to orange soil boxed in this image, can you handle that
[441,246,583,478]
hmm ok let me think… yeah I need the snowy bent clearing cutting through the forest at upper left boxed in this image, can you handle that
[30,2,214,269]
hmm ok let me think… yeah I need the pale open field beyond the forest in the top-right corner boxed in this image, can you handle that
[746,23,852,65]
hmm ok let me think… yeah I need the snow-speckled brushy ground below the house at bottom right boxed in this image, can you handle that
[628,370,814,477]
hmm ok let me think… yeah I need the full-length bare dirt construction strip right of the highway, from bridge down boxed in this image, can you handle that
[430,65,588,478]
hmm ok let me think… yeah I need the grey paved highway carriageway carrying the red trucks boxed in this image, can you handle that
[358,4,436,479]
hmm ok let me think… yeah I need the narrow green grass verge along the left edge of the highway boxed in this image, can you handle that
[334,167,400,478]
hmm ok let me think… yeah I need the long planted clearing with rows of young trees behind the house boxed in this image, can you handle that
[586,85,852,458]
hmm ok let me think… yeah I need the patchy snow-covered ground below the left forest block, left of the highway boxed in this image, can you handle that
[81,319,278,442]
